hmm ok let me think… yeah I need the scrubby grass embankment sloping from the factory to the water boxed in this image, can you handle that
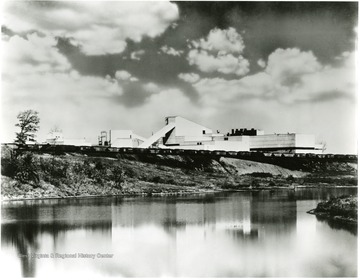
[1,147,357,199]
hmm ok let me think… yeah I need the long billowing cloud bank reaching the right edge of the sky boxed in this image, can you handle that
[194,49,355,105]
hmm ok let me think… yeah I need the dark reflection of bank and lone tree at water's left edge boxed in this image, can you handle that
[1,200,112,277]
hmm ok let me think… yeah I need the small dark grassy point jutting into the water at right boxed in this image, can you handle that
[308,196,358,224]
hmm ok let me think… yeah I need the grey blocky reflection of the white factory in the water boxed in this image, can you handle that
[111,192,296,237]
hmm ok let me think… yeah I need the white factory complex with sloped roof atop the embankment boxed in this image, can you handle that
[99,116,322,154]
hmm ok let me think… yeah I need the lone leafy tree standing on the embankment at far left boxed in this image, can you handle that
[15,110,40,144]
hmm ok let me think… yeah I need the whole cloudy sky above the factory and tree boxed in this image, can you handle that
[1,1,358,153]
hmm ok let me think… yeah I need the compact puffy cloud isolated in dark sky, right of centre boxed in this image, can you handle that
[187,27,249,76]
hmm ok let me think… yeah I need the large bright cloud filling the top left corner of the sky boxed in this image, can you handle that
[3,1,179,55]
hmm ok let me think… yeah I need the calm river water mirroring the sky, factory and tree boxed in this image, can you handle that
[1,188,357,277]
